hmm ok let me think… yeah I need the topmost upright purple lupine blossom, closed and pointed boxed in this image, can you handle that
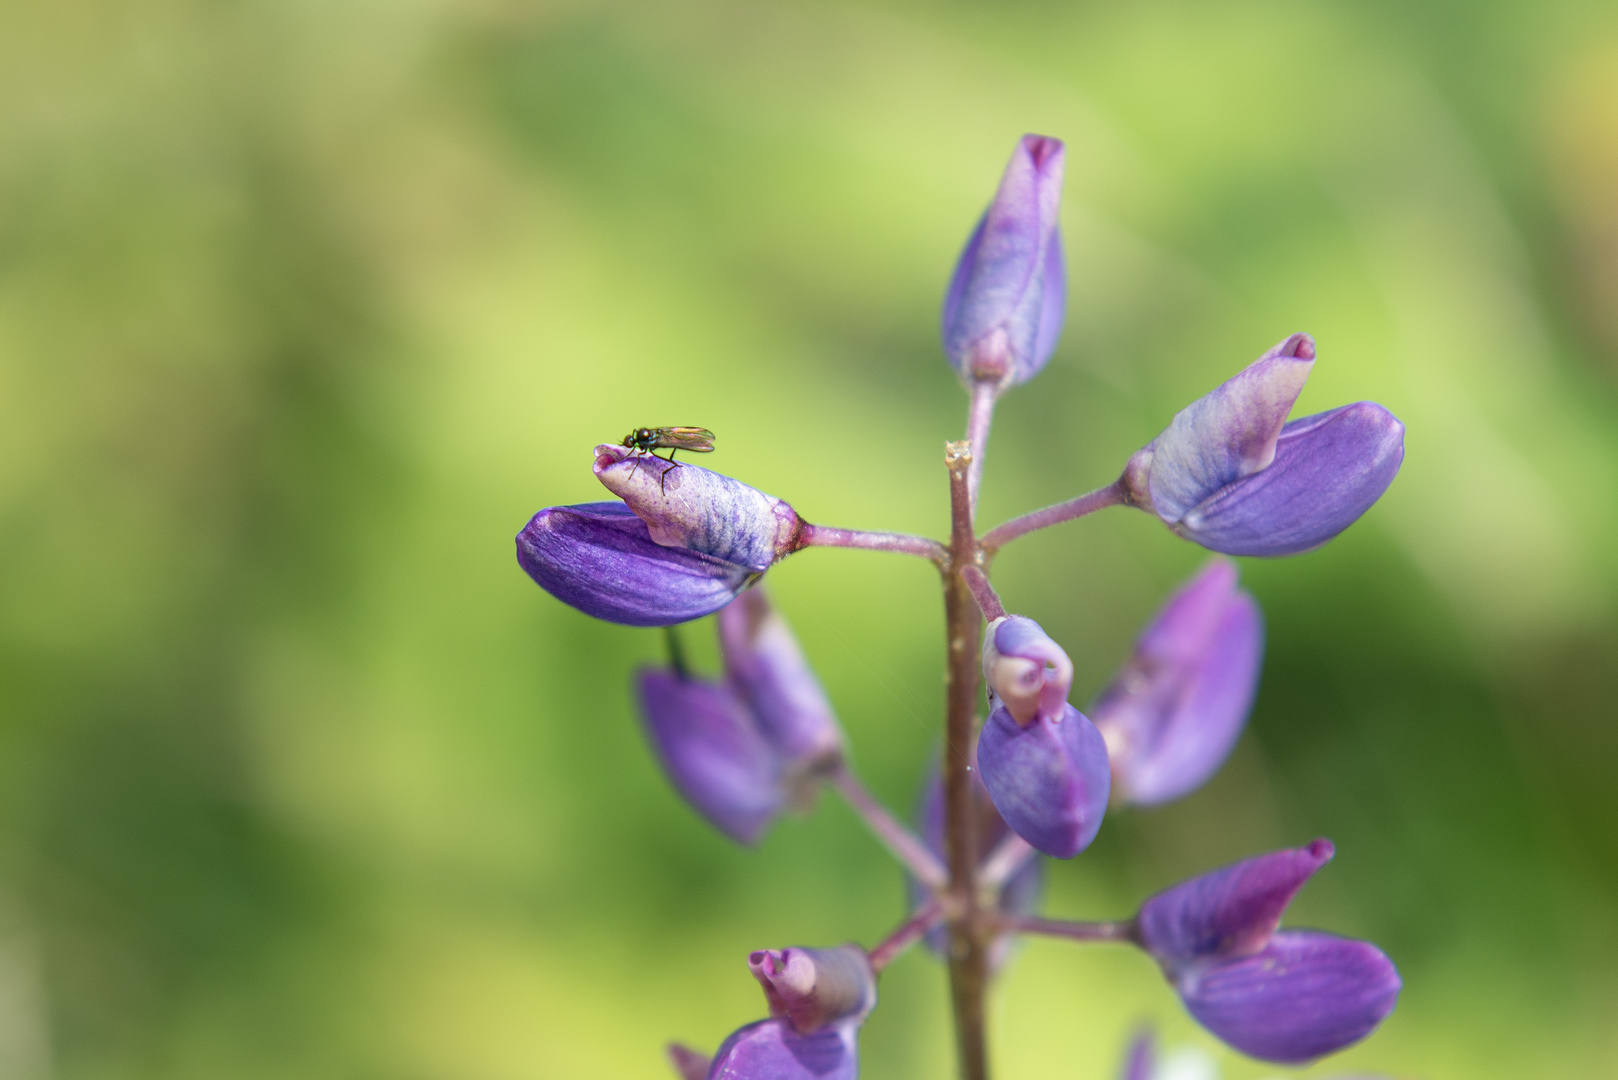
[943,134,1068,387]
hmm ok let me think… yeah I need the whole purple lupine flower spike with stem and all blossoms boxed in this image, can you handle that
[516,136,1404,1080]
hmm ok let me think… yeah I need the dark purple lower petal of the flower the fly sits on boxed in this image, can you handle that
[516,502,759,627]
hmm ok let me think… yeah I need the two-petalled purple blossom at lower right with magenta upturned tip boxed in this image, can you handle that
[1136,840,1400,1064]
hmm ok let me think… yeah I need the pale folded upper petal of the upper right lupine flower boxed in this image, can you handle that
[1150,334,1315,525]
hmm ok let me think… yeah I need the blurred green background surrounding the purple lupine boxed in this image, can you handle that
[0,0,1618,1080]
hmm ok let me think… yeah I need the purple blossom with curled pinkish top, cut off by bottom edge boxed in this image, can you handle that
[709,946,877,1080]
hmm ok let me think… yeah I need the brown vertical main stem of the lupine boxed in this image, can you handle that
[943,442,989,1080]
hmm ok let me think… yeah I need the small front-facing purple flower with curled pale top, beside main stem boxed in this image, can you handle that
[977,615,1112,858]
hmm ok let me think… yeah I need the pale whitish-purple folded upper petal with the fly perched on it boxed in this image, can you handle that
[595,444,803,573]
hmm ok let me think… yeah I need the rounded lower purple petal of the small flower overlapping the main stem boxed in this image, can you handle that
[977,704,1112,858]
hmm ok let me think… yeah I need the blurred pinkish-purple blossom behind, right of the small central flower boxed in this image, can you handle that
[1091,559,1264,806]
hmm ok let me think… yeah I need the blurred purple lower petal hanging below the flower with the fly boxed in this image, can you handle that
[636,669,785,844]
